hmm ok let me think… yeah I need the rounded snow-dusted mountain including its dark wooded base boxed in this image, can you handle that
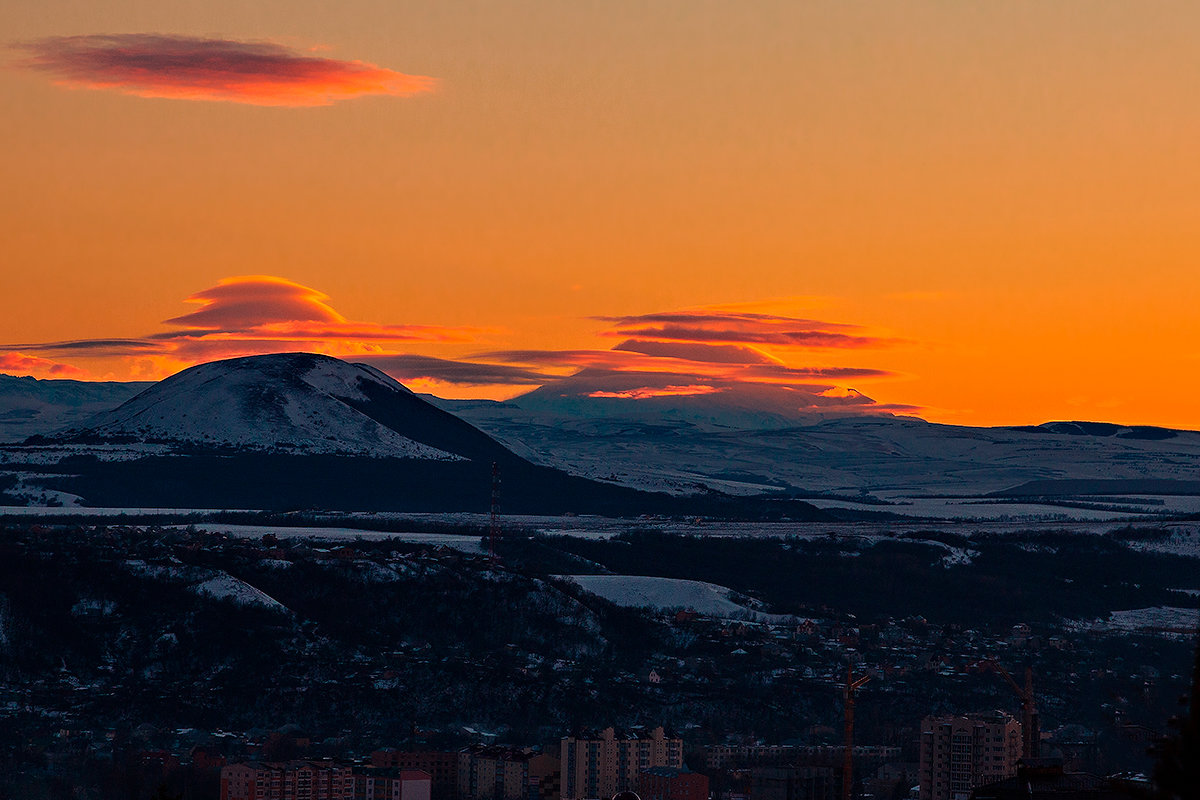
[0,353,832,519]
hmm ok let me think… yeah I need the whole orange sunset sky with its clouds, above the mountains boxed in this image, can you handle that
[0,0,1200,428]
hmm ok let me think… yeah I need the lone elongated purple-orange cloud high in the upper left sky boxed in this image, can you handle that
[18,34,436,106]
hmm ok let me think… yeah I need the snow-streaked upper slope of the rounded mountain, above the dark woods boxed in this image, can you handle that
[72,353,460,461]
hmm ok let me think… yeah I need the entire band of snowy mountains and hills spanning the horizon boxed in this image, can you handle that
[0,354,1200,518]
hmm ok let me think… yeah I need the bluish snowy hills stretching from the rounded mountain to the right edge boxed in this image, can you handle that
[430,398,1200,497]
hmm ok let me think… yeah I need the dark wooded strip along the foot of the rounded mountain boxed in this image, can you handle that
[37,453,840,522]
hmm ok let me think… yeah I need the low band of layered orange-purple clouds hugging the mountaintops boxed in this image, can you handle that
[0,284,913,414]
